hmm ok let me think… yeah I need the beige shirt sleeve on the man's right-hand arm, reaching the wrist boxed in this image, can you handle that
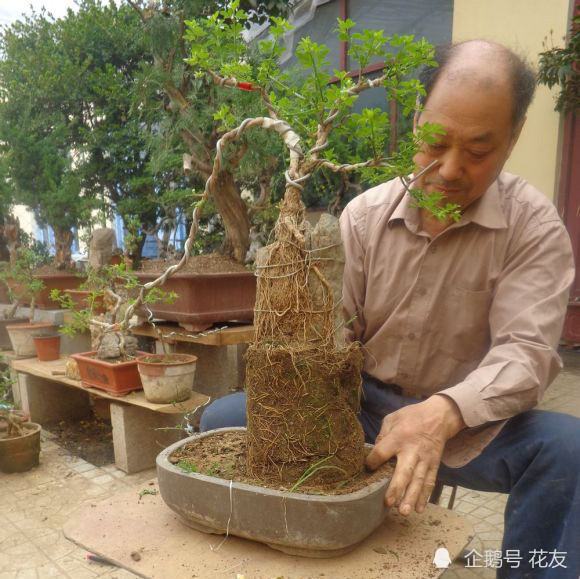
[439,220,574,427]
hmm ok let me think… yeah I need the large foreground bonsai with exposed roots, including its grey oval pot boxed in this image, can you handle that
[101,1,456,556]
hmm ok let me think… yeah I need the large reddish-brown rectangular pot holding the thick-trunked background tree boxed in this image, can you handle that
[137,271,256,327]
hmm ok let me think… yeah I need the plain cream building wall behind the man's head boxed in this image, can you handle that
[453,0,570,198]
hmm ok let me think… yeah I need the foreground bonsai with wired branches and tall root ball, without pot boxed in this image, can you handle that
[103,1,458,494]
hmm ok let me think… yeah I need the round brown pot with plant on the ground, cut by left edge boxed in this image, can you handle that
[0,368,41,473]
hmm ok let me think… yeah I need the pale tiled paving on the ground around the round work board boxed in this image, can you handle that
[0,351,580,579]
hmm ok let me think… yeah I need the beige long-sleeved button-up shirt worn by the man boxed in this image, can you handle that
[341,173,574,467]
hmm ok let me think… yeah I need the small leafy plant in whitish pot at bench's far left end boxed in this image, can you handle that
[0,249,55,358]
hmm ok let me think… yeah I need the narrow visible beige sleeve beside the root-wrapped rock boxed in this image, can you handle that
[340,199,366,342]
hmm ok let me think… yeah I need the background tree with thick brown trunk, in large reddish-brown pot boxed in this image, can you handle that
[128,0,293,263]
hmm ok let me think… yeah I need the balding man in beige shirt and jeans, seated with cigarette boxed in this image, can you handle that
[201,41,580,579]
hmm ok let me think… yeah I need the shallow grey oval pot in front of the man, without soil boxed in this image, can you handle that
[157,428,389,558]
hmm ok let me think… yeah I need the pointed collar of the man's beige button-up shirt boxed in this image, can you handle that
[389,179,507,233]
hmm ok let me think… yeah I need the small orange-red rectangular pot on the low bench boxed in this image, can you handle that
[70,352,145,396]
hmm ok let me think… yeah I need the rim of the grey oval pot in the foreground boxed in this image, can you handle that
[155,426,390,503]
